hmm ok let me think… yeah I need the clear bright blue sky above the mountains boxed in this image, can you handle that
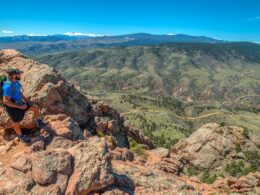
[0,0,260,42]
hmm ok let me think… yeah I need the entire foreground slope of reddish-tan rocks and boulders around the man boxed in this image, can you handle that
[0,50,260,195]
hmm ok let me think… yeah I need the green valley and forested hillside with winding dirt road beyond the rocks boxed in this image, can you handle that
[35,43,260,148]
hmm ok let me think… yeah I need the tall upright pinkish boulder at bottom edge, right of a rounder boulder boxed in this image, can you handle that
[66,138,114,194]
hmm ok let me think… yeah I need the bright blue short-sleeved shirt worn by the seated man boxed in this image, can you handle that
[3,79,23,106]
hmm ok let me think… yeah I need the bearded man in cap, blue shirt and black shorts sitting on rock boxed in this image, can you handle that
[3,68,45,143]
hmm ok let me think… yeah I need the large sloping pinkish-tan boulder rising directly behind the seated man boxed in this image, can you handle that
[0,50,91,128]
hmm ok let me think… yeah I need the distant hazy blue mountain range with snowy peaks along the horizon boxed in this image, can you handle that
[0,33,224,55]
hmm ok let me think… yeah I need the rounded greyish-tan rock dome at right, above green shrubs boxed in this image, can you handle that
[171,123,260,170]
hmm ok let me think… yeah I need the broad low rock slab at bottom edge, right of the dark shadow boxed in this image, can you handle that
[112,159,199,195]
